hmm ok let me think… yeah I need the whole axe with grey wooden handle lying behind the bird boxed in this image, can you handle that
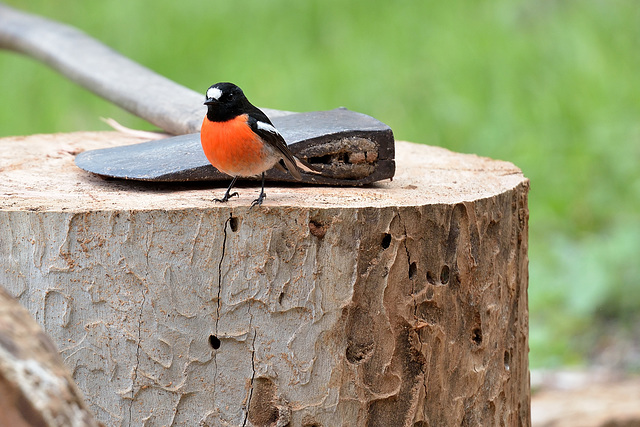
[0,3,395,185]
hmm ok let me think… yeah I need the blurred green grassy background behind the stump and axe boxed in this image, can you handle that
[0,0,640,371]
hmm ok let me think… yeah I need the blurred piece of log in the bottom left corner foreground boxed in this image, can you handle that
[0,287,101,427]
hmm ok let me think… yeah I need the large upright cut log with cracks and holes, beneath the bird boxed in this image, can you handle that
[0,132,530,427]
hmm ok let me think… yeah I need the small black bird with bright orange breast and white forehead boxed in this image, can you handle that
[200,82,302,207]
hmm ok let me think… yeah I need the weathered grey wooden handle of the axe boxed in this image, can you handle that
[0,3,287,135]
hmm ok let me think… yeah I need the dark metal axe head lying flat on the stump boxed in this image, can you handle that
[75,108,395,185]
